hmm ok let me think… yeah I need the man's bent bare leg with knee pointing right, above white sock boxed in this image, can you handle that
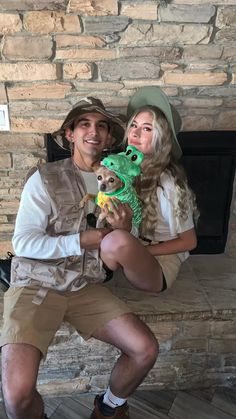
[93,313,158,398]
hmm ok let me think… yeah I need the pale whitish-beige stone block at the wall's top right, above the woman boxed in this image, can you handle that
[159,4,216,23]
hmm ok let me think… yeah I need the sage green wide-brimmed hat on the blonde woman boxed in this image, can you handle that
[127,86,182,159]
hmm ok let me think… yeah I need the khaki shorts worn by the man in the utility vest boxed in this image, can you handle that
[0,284,131,357]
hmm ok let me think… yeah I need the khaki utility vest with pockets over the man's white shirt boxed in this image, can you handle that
[11,158,105,291]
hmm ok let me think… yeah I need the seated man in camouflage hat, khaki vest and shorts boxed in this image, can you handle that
[0,98,158,419]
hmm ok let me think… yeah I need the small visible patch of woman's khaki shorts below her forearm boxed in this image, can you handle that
[155,255,182,288]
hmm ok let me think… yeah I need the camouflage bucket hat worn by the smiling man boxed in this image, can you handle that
[52,96,125,150]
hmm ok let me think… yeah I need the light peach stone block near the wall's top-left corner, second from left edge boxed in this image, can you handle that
[24,11,81,35]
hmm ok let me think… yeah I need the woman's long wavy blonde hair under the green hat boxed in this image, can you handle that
[124,106,199,237]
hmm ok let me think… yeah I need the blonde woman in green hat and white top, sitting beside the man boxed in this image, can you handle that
[102,87,198,292]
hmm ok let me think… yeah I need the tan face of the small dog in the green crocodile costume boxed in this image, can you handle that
[95,166,123,193]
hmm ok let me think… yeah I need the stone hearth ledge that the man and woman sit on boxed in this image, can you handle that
[0,255,236,395]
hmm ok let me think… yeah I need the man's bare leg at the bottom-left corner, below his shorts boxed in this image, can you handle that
[2,343,44,419]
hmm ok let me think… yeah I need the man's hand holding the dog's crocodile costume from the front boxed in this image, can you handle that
[102,199,133,231]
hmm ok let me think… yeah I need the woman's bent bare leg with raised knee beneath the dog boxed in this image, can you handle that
[101,230,163,292]
